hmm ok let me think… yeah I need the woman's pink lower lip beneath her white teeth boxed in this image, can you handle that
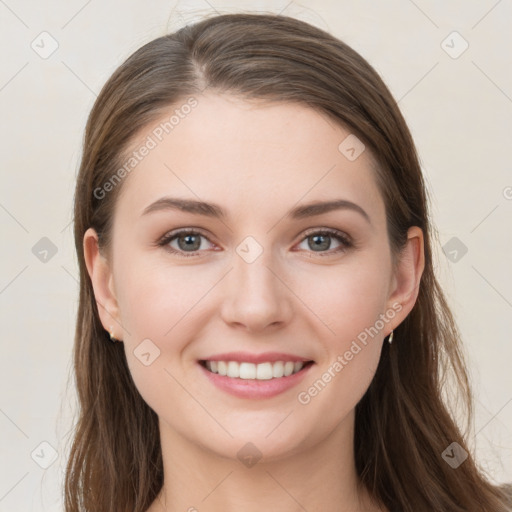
[198,363,314,400]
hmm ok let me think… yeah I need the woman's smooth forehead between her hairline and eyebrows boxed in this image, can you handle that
[113,93,384,226]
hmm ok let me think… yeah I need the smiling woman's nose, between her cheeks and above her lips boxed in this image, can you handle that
[221,247,293,333]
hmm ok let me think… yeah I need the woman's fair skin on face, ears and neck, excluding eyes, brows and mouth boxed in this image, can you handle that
[84,93,424,512]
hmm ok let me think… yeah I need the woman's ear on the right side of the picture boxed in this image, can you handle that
[386,226,425,336]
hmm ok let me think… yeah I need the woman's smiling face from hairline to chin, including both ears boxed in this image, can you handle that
[84,94,423,459]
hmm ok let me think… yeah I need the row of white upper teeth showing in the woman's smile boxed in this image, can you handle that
[206,361,304,380]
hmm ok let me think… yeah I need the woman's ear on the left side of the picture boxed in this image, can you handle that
[83,228,123,340]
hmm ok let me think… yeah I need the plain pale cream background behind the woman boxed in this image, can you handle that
[0,0,512,512]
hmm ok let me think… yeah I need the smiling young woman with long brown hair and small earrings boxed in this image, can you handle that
[65,14,510,512]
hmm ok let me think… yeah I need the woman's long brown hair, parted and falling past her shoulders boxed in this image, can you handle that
[65,14,508,512]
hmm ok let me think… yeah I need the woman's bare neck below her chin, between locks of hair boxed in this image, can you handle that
[152,414,382,512]
